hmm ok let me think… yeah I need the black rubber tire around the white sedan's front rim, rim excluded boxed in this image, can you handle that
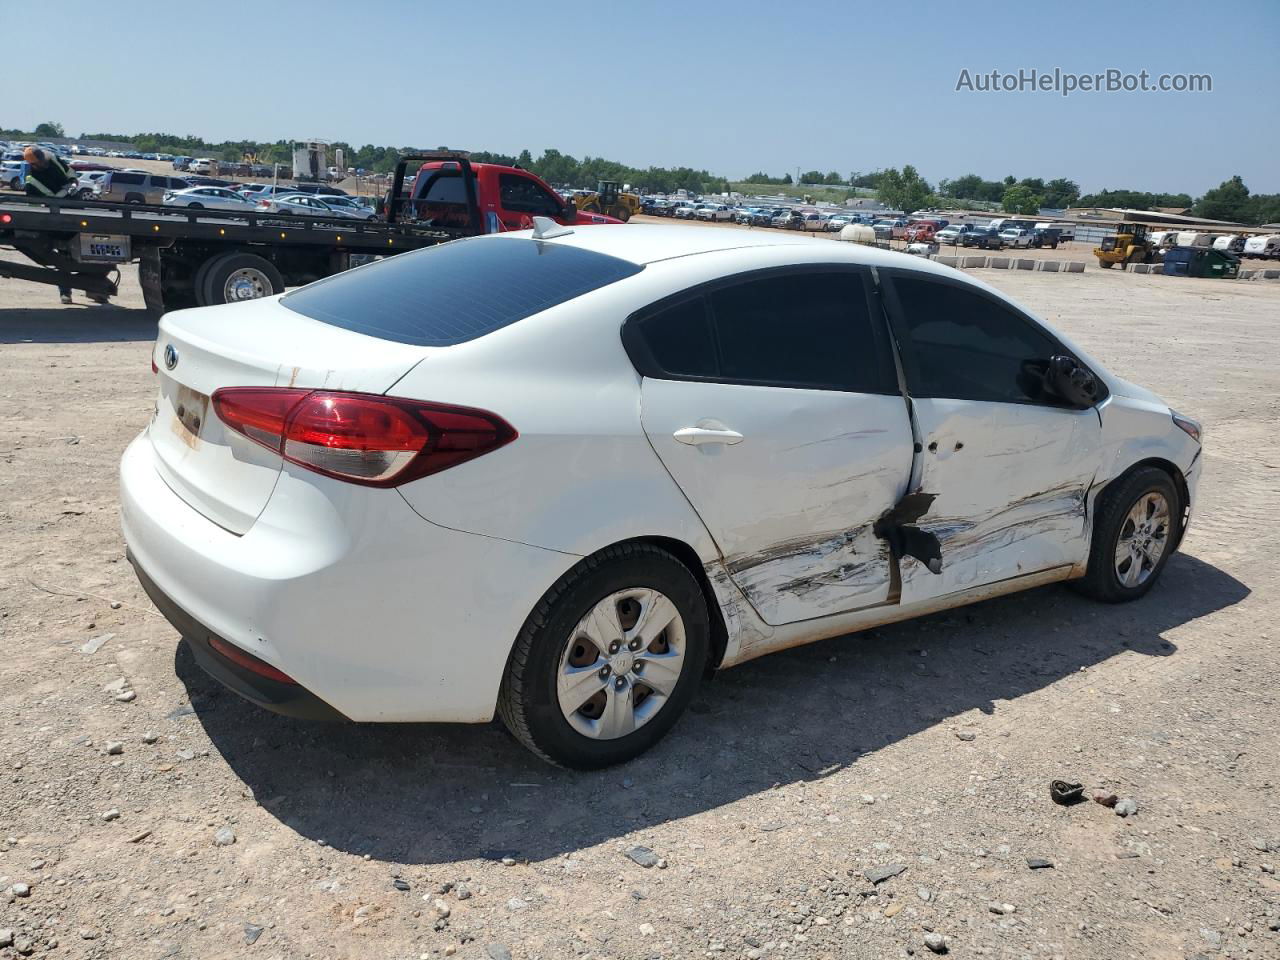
[1074,467,1184,603]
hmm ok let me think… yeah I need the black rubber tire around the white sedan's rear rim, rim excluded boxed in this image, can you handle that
[498,544,710,769]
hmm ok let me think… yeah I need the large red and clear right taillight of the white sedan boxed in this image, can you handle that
[214,387,517,486]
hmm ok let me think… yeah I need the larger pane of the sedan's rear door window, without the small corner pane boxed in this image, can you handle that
[709,271,887,393]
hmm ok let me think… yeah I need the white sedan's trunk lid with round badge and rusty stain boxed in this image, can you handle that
[148,297,433,534]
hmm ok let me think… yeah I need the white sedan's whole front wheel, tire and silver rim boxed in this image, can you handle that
[1078,467,1184,603]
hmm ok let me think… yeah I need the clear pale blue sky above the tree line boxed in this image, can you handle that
[12,0,1280,195]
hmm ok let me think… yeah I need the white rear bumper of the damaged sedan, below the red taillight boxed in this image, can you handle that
[120,433,577,723]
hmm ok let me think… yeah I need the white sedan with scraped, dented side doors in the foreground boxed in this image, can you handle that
[120,218,1203,768]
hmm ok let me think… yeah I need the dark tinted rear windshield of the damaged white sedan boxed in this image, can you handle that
[280,238,643,347]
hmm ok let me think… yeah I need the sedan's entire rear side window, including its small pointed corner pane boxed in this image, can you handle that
[623,270,896,393]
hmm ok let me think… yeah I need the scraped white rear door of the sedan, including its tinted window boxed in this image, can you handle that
[631,269,911,625]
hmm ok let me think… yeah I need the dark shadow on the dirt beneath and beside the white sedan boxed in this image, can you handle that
[175,554,1249,864]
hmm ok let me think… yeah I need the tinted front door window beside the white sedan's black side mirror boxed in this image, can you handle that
[893,276,1059,403]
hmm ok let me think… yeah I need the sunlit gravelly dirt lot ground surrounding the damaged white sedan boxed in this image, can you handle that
[0,249,1280,960]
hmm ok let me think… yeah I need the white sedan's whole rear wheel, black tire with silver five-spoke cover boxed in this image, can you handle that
[498,544,709,769]
